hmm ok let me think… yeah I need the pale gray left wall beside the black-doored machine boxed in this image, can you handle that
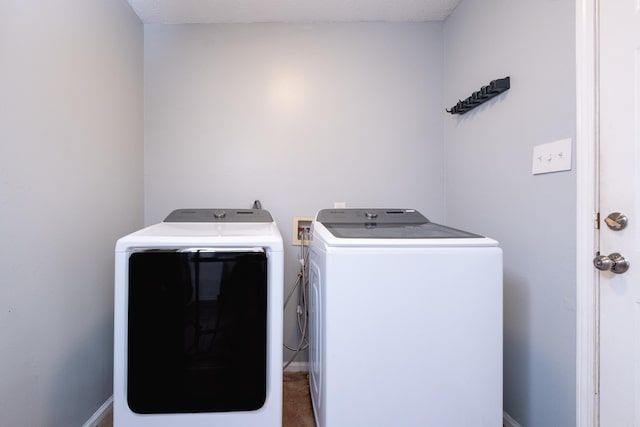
[0,0,143,426]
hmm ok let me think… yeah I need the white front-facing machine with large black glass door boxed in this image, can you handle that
[113,209,284,427]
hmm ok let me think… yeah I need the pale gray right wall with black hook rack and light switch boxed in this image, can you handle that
[444,0,576,427]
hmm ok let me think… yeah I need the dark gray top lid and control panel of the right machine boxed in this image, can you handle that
[316,209,482,239]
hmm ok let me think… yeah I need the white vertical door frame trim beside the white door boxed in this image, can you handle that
[576,0,599,427]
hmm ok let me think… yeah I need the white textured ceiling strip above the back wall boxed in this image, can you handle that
[128,0,460,24]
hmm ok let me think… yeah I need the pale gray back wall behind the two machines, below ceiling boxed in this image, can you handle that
[145,23,444,360]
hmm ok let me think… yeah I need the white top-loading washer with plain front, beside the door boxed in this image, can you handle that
[309,209,503,427]
